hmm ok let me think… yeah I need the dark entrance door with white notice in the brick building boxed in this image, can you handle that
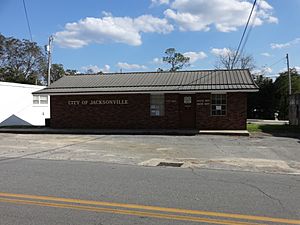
[179,94,196,129]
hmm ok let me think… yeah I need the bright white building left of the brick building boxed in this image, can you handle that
[0,82,50,126]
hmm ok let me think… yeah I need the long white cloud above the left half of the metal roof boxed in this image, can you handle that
[55,12,173,48]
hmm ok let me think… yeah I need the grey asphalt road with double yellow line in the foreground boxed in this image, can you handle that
[0,158,300,225]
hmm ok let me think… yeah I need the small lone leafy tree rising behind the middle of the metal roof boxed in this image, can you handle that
[163,48,190,71]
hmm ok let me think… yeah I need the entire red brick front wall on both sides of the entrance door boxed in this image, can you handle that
[50,93,247,130]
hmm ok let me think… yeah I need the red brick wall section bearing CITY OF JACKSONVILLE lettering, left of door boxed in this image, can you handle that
[50,94,179,129]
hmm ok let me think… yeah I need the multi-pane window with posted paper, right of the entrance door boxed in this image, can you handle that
[211,94,227,116]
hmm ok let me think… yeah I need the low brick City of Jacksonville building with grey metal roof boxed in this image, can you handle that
[33,70,258,130]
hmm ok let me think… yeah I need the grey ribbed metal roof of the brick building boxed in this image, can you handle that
[33,69,258,95]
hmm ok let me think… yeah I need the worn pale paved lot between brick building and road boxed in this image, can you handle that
[0,133,300,174]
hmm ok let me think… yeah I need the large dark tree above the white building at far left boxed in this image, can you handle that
[0,34,46,84]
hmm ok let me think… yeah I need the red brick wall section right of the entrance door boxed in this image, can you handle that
[196,92,247,130]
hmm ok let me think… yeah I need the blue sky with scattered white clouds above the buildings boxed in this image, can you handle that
[0,0,300,77]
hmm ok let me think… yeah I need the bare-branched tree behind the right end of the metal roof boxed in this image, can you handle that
[215,48,255,70]
